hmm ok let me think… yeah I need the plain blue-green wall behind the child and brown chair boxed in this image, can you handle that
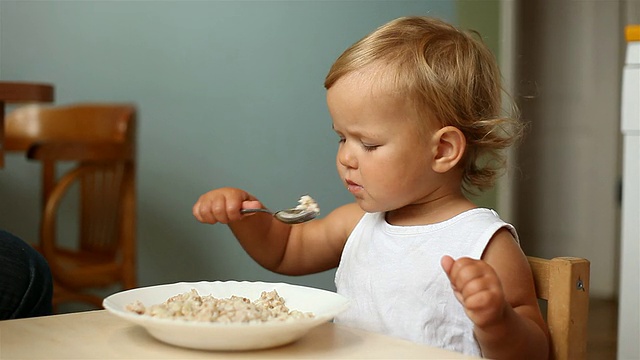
[0,0,500,296]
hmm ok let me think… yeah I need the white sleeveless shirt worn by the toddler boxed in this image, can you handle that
[335,208,518,356]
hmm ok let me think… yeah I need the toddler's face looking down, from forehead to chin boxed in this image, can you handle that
[327,71,435,212]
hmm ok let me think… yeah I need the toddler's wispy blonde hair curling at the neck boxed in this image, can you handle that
[324,16,522,192]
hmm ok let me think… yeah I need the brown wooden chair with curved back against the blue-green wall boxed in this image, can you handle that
[5,104,136,308]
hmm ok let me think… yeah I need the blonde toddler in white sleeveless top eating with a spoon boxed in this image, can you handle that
[193,17,548,359]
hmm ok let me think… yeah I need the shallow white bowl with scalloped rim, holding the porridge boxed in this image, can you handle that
[103,281,349,350]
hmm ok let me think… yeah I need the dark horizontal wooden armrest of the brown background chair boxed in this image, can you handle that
[27,141,133,161]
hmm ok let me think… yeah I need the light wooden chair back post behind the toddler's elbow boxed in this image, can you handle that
[528,256,590,360]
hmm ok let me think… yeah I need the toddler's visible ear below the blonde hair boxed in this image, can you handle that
[432,126,467,173]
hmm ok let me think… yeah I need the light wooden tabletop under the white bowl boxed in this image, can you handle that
[0,310,471,359]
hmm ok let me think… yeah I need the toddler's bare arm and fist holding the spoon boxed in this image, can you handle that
[193,188,364,275]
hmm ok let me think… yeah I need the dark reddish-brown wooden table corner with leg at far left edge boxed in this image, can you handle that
[0,81,53,168]
